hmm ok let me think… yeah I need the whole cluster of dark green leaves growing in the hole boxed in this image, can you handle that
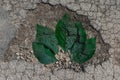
[32,14,96,64]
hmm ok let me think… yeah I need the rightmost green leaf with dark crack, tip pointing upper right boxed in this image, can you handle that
[71,38,96,63]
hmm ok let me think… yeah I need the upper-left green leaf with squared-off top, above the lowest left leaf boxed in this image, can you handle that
[35,24,58,54]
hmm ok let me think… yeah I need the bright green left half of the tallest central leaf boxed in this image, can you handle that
[55,14,71,51]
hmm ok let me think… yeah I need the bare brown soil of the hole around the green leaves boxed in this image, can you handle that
[5,3,110,70]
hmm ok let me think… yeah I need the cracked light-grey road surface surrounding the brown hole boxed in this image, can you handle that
[0,0,120,80]
